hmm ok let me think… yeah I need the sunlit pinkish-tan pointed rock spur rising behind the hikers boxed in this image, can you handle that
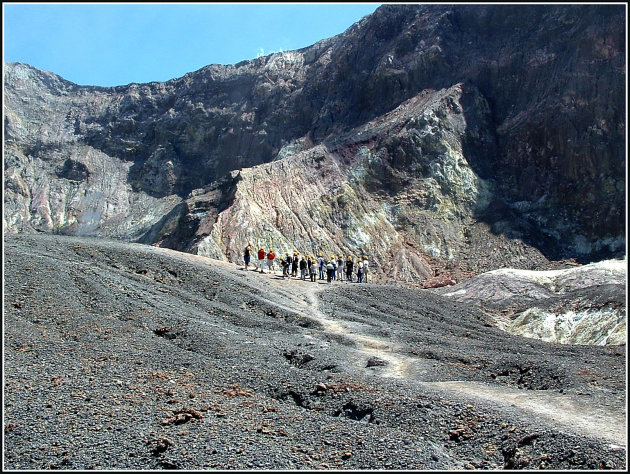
[140,84,547,282]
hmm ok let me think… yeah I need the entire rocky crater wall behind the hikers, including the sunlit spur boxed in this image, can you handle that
[3,5,626,282]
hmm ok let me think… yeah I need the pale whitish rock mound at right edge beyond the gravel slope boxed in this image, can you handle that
[435,259,627,345]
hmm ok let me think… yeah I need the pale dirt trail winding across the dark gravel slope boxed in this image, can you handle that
[130,249,627,447]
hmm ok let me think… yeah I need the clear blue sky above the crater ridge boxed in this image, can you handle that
[2,2,380,86]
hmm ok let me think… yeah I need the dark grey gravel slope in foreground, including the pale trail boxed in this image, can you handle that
[3,234,627,470]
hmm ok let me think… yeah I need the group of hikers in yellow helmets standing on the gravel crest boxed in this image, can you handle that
[243,242,369,283]
